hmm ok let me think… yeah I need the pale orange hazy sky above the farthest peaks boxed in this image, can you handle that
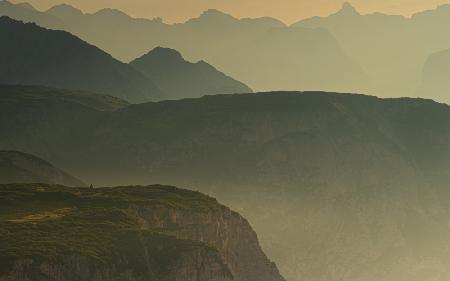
[13,0,450,23]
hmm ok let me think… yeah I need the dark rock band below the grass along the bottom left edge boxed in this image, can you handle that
[0,249,233,281]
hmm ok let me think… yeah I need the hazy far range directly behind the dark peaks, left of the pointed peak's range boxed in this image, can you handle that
[0,0,370,92]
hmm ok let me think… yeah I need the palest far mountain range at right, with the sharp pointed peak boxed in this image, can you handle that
[293,3,450,100]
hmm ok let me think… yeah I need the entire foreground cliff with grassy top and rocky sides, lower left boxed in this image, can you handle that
[0,184,284,281]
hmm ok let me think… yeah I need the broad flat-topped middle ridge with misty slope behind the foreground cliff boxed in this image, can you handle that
[0,87,450,281]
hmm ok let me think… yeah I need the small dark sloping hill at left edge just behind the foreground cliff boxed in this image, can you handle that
[0,151,86,187]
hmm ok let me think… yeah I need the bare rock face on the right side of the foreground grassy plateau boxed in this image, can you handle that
[133,202,282,281]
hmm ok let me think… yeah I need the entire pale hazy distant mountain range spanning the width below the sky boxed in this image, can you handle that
[4,1,450,102]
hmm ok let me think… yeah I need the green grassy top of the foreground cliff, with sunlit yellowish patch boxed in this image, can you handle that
[0,184,223,270]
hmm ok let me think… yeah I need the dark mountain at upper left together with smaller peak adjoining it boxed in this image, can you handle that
[0,14,252,103]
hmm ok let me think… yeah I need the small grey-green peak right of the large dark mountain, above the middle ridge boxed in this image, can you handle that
[130,47,252,99]
